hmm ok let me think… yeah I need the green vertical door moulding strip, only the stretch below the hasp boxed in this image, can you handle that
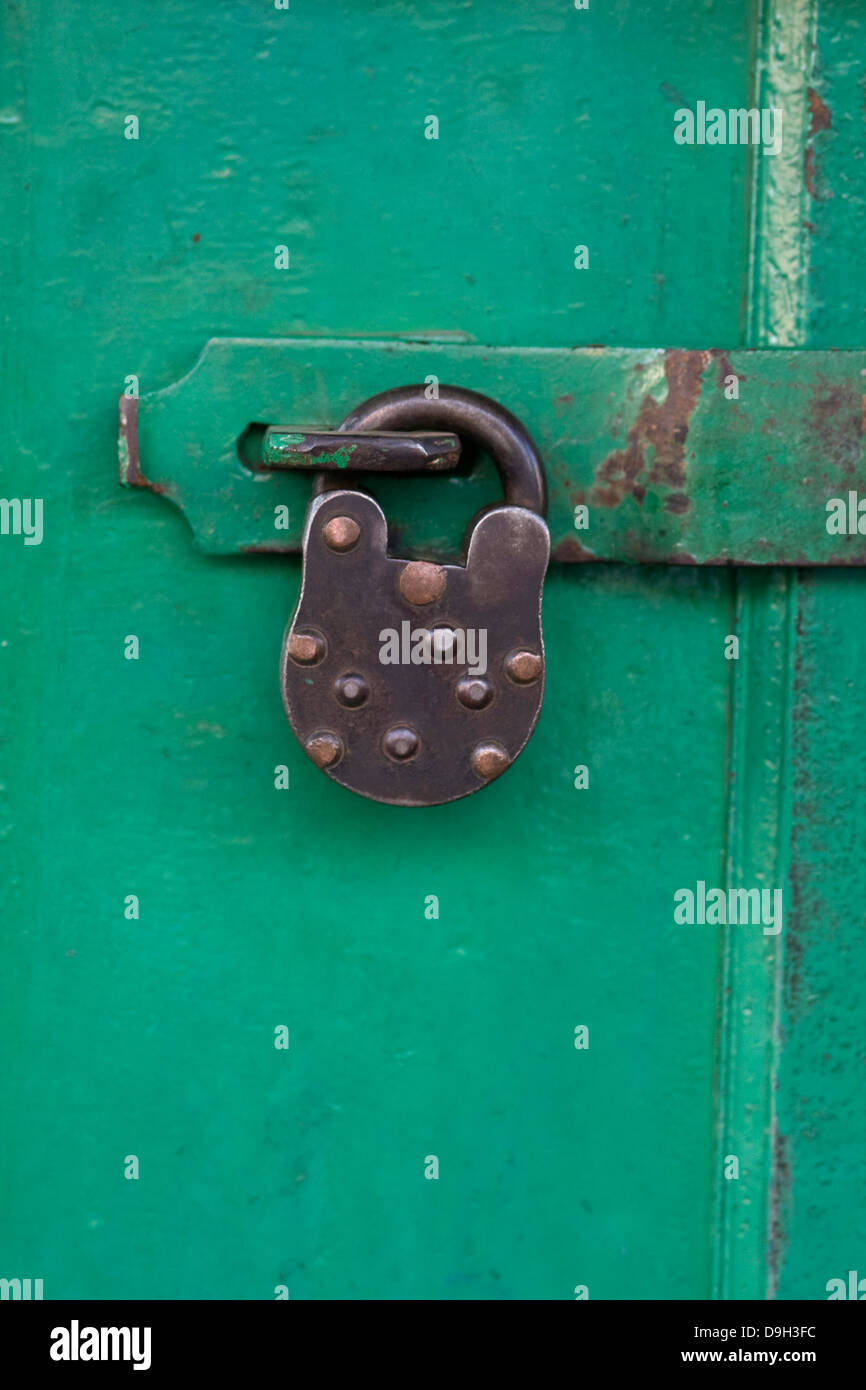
[714,570,792,1298]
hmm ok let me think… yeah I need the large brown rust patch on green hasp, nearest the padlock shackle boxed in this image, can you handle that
[592,349,710,507]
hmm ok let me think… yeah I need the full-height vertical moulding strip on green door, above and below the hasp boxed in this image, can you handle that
[713,0,819,1298]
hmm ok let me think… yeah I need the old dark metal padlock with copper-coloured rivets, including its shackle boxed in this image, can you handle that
[272,386,550,806]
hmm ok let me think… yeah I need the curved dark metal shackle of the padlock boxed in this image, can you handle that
[339,385,548,517]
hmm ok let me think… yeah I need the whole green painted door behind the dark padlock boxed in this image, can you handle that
[0,0,866,1300]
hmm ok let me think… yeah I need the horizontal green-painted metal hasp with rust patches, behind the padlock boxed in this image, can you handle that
[120,338,866,566]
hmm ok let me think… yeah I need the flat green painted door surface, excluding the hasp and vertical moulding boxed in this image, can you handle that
[0,0,863,1298]
